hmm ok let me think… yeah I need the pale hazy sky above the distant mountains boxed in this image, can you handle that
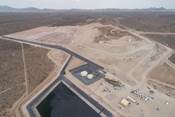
[0,0,175,9]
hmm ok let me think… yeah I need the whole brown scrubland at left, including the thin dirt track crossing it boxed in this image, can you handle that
[0,39,54,117]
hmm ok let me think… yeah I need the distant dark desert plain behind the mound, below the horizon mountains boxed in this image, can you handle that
[0,10,175,35]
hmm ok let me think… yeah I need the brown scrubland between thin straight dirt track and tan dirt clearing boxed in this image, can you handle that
[24,44,54,92]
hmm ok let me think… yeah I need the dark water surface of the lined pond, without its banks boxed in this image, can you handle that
[37,83,100,117]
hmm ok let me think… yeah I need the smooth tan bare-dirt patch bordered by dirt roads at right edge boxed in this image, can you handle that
[148,63,175,86]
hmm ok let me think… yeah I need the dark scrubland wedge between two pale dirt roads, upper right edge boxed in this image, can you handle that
[144,34,175,49]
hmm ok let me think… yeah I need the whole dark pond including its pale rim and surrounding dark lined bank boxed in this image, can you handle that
[27,76,112,117]
